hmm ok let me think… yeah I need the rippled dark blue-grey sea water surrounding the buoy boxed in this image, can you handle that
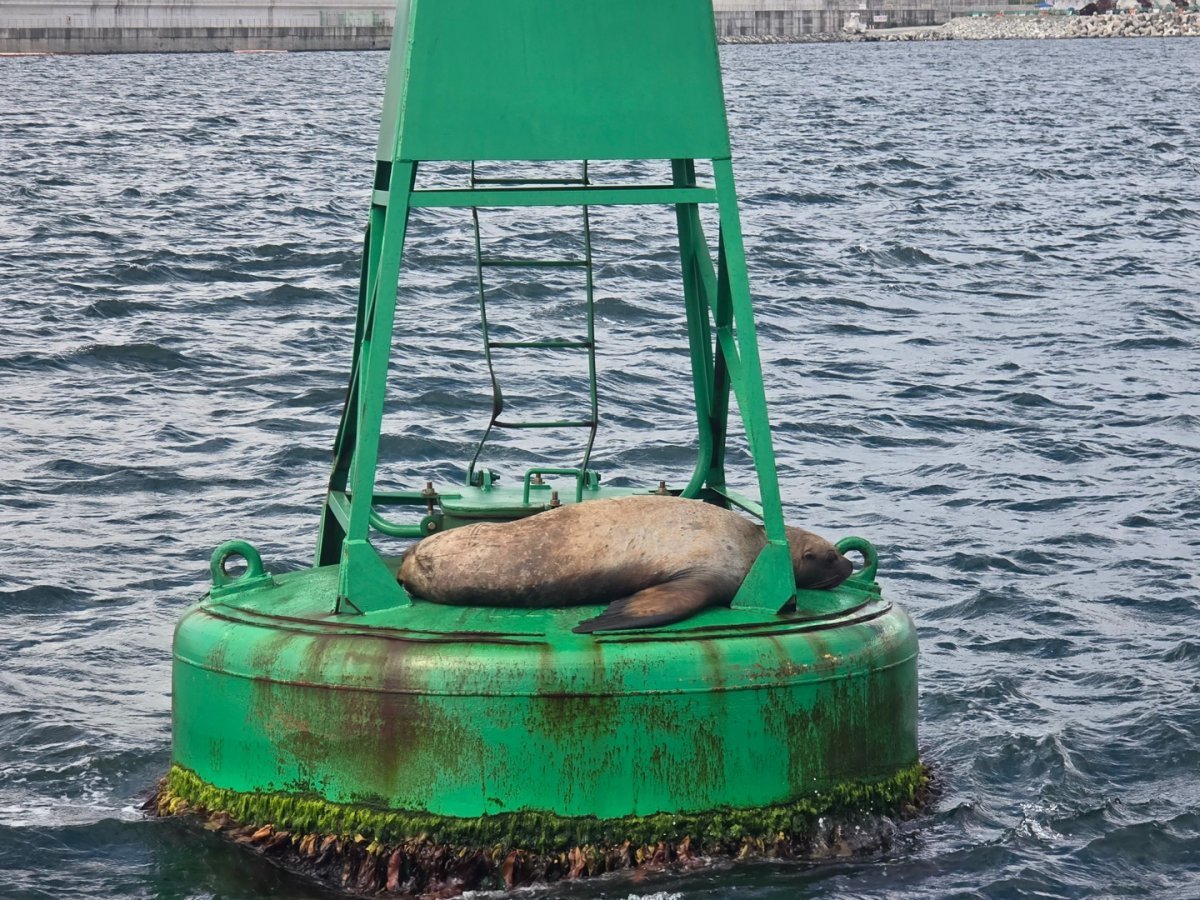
[0,38,1200,900]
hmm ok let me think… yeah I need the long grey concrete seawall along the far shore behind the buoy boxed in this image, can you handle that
[0,0,1004,53]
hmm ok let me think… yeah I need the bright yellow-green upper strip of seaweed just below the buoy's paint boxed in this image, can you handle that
[157,762,929,853]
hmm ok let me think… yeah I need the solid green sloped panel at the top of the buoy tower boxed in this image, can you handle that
[379,0,730,162]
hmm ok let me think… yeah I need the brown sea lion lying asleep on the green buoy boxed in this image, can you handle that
[397,494,853,634]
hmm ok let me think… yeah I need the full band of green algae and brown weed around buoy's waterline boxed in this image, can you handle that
[146,763,929,896]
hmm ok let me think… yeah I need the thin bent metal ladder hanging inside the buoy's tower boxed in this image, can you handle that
[467,160,599,499]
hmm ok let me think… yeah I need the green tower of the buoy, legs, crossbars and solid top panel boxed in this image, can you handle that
[317,0,816,613]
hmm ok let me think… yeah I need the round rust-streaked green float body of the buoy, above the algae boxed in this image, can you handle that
[174,566,917,818]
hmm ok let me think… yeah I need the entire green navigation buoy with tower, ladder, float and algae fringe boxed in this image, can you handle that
[155,0,925,893]
